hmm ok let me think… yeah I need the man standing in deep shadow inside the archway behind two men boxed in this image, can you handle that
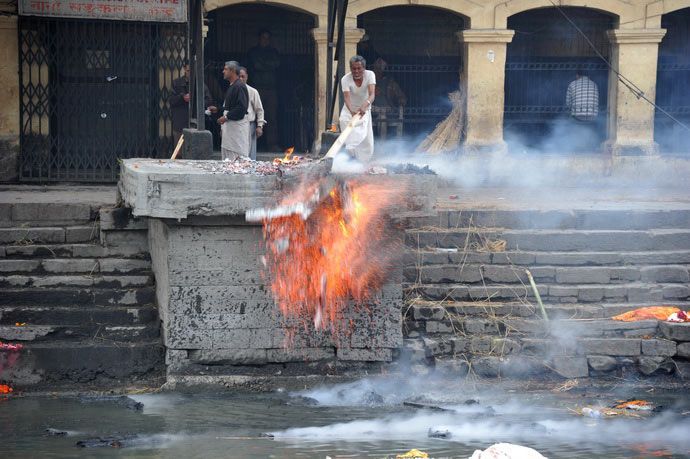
[247,30,281,152]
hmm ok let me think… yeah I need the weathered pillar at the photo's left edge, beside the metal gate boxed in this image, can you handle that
[0,16,19,182]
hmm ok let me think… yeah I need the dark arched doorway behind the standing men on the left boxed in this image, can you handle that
[205,3,316,153]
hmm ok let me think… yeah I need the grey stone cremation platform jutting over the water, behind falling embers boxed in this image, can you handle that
[118,159,403,385]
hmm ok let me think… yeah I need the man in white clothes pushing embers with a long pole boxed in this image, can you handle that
[339,56,376,162]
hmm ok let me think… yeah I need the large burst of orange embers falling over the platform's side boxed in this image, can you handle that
[264,180,401,333]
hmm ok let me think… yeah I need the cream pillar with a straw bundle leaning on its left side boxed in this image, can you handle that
[457,29,515,152]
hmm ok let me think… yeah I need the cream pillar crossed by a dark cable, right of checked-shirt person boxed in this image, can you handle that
[605,29,666,156]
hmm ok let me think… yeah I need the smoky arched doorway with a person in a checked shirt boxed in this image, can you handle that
[504,7,614,153]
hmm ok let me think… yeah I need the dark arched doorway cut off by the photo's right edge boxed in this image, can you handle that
[654,8,690,154]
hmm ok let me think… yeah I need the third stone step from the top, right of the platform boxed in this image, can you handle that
[404,248,690,267]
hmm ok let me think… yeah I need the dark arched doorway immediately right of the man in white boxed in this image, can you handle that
[357,6,466,138]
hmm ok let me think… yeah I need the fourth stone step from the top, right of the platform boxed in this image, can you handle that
[404,263,690,284]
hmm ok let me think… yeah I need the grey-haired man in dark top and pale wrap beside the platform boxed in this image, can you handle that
[218,61,249,161]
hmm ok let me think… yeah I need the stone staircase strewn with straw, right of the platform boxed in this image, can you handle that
[403,210,690,379]
